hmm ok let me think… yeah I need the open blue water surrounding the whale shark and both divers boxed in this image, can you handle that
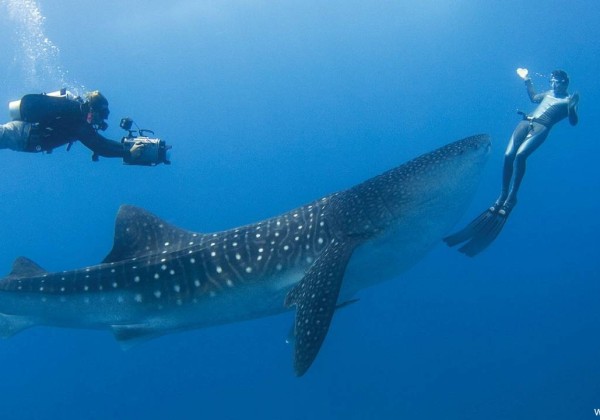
[0,0,600,419]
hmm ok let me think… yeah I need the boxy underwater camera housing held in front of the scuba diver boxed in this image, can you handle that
[119,117,171,166]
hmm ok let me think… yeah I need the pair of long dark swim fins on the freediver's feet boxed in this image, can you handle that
[444,204,514,257]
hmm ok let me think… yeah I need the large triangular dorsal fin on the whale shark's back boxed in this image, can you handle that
[102,205,202,263]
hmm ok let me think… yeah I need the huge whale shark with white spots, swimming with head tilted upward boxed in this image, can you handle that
[0,134,490,376]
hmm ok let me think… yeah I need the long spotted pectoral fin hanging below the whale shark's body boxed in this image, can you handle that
[285,240,354,376]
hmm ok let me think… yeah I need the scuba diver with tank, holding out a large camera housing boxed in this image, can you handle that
[0,89,170,166]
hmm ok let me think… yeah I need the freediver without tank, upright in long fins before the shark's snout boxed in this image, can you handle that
[444,68,579,257]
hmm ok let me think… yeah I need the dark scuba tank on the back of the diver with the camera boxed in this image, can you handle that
[8,88,78,122]
